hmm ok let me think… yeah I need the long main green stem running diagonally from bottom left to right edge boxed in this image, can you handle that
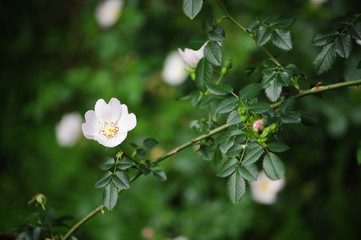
[61,78,361,240]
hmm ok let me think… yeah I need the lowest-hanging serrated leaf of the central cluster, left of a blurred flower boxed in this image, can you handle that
[227,171,246,204]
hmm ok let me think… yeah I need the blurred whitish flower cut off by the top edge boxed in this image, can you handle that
[95,0,123,28]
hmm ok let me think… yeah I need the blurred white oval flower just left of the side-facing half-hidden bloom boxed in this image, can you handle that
[162,52,188,86]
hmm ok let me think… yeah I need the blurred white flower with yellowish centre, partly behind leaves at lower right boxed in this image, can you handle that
[250,171,285,204]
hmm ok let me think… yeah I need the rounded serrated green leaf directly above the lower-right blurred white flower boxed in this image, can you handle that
[263,152,285,180]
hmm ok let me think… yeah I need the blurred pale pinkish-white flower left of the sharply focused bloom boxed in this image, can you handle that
[55,112,83,147]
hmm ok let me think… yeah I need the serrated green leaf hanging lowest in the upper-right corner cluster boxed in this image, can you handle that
[313,43,336,75]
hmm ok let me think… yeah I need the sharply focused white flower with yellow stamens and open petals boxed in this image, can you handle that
[82,98,137,147]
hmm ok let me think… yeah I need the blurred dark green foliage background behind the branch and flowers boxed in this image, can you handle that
[0,0,361,240]
